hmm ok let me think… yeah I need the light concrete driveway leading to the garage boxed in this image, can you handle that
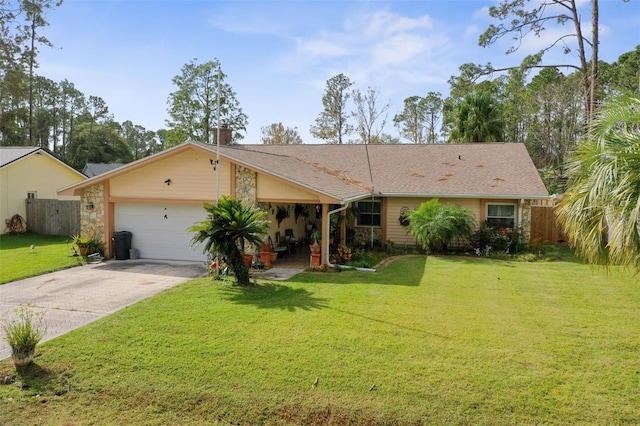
[0,259,206,359]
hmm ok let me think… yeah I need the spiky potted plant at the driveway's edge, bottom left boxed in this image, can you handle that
[2,305,46,367]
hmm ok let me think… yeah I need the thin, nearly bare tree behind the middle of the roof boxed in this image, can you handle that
[352,87,391,144]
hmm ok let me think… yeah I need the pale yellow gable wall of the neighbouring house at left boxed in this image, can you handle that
[0,154,85,228]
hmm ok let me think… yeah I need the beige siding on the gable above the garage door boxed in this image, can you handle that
[110,150,231,201]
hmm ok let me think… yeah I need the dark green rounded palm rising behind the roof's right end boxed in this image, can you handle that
[449,90,504,142]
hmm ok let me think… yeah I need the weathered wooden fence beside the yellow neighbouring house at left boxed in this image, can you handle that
[26,198,80,235]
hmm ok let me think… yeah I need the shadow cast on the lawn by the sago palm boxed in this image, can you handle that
[223,283,327,312]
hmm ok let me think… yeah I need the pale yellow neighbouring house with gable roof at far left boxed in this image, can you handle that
[0,147,86,233]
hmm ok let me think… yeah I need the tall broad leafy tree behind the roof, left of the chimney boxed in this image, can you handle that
[167,59,247,144]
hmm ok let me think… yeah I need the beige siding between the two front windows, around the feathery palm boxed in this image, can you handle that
[386,198,481,245]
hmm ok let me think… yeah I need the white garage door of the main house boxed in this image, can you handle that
[115,203,207,261]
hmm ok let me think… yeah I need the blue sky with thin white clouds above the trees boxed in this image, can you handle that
[37,0,640,143]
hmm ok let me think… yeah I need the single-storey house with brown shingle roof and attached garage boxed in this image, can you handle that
[60,142,549,262]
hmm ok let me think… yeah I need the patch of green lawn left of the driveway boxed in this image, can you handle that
[0,234,83,284]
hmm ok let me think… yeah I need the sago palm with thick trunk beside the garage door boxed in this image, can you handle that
[189,196,270,286]
